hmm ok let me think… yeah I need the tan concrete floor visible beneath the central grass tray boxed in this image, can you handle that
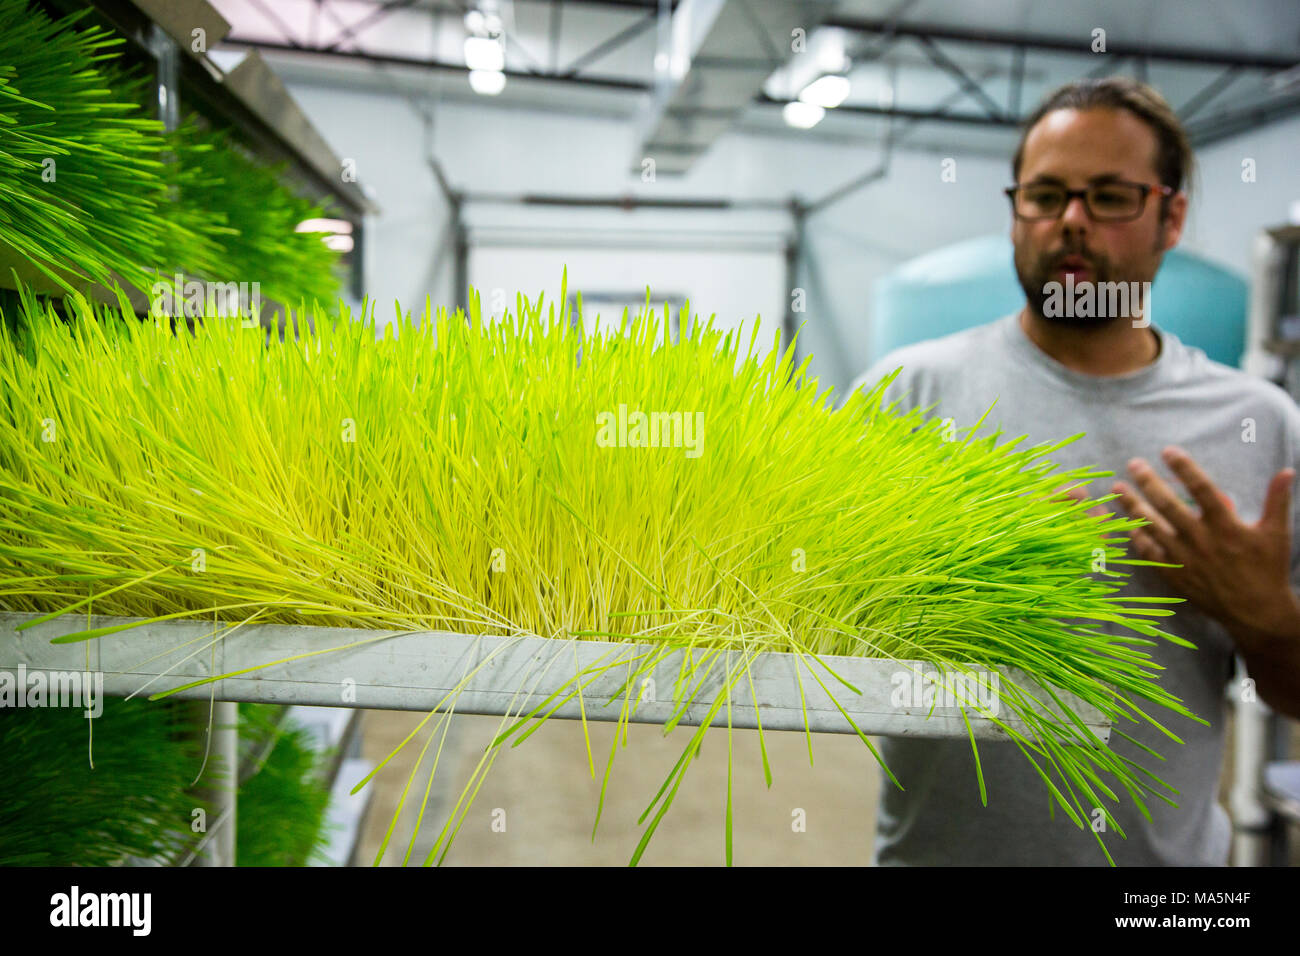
[358,711,879,866]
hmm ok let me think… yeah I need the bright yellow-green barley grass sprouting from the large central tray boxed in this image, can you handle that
[0,278,1191,862]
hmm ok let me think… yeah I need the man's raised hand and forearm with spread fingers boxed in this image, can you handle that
[1113,447,1300,718]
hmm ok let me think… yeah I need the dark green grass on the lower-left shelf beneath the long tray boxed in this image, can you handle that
[0,697,329,866]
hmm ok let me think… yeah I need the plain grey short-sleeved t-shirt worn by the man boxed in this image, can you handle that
[853,315,1300,866]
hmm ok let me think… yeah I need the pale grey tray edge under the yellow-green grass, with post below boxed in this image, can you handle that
[0,611,1110,865]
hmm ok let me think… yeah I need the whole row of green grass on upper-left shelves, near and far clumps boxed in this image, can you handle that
[0,0,338,306]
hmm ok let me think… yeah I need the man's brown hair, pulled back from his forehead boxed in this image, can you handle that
[1011,77,1193,201]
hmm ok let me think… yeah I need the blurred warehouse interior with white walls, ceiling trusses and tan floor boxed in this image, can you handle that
[0,0,1300,866]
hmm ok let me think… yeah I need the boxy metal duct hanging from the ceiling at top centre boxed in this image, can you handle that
[632,0,836,174]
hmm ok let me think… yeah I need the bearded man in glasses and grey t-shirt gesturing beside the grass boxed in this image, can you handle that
[854,79,1300,866]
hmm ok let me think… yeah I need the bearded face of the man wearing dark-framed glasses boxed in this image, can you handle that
[1011,109,1187,326]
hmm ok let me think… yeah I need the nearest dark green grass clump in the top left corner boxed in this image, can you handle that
[0,0,175,297]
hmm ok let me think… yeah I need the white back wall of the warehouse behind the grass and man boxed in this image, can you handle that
[291,70,1300,388]
